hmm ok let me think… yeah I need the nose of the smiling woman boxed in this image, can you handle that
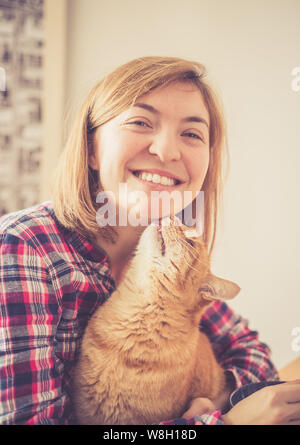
[149,133,181,162]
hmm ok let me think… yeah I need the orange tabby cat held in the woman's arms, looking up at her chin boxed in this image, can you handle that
[73,219,239,425]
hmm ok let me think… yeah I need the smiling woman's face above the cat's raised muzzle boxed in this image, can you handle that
[90,82,210,225]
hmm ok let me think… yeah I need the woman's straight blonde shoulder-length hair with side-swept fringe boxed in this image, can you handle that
[52,57,227,252]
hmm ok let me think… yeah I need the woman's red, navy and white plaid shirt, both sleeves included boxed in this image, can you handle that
[0,201,278,425]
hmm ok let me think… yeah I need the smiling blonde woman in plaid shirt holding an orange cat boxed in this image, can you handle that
[0,57,300,424]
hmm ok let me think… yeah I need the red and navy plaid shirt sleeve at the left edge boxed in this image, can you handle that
[0,233,68,425]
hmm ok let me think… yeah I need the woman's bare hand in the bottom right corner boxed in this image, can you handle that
[222,380,300,425]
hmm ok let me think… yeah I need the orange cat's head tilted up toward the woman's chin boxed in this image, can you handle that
[137,217,240,301]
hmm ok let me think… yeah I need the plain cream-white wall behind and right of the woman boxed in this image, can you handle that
[67,0,300,367]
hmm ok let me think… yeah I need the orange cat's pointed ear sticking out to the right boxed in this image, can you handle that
[198,274,241,300]
